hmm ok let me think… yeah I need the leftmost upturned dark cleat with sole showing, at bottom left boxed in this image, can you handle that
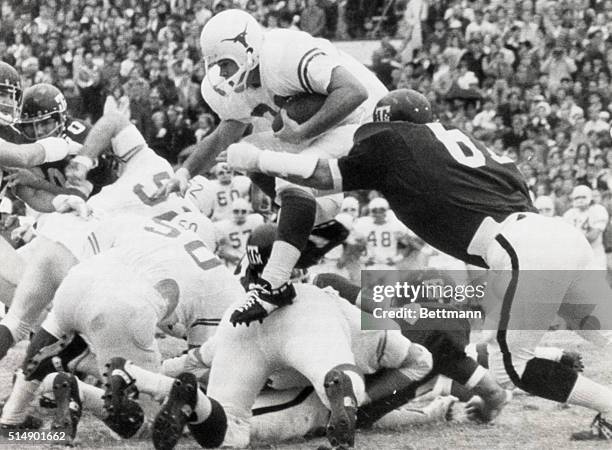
[51,372,83,443]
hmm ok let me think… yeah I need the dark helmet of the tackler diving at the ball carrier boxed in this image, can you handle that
[374,89,433,124]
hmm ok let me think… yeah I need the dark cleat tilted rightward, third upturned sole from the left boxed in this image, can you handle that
[153,372,198,450]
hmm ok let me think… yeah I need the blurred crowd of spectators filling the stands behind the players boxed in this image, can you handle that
[0,0,612,278]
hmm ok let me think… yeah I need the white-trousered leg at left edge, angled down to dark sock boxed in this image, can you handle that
[0,237,77,358]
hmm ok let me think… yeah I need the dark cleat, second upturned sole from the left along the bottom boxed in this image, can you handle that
[102,358,144,439]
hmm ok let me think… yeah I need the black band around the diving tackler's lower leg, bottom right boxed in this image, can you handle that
[518,358,578,403]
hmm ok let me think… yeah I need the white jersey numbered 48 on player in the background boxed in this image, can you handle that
[352,216,407,264]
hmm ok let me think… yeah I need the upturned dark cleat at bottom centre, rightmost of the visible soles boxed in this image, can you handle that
[324,369,357,450]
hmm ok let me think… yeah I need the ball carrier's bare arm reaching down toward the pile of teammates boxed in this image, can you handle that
[155,120,248,196]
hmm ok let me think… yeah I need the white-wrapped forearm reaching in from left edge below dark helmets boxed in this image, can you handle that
[0,137,68,167]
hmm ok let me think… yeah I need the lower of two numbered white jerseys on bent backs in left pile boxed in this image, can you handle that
[88,216,244,345]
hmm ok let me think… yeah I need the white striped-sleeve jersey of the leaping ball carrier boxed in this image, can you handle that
[202,29,387,124]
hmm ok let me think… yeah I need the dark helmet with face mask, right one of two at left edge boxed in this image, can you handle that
[19,83,67,141]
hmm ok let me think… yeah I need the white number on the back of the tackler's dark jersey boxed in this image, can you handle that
[427,123,512,169]
